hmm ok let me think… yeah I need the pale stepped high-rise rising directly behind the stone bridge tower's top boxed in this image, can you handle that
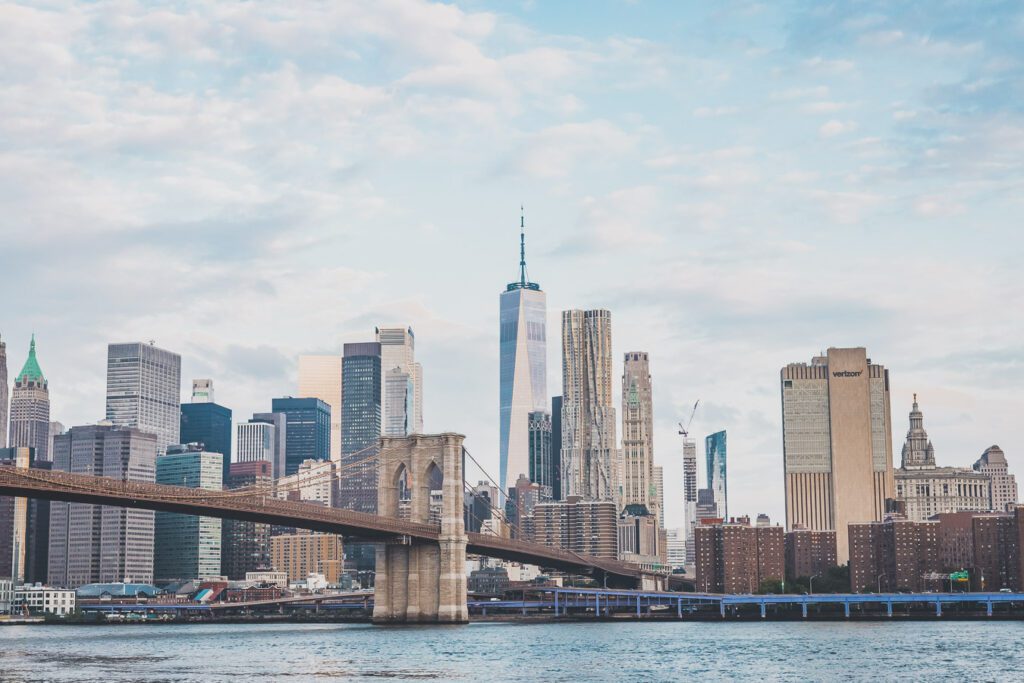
[375,328,423,436]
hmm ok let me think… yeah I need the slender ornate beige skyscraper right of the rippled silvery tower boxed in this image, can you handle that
[622,351,662,521]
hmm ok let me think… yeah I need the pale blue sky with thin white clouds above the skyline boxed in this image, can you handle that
[0,0,1024,526]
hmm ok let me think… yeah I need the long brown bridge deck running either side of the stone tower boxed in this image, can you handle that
[0,466,659,582]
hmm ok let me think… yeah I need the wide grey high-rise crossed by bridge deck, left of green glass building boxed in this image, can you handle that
[47,424,157,588]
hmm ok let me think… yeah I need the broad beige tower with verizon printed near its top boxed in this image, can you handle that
[780,347,894,564]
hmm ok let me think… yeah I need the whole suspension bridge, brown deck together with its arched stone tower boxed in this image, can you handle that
[0,432,665,623]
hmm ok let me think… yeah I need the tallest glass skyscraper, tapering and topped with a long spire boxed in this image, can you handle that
[498,217,548,492]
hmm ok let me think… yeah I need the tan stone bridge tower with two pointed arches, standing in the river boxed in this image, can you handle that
[374,432,469,624]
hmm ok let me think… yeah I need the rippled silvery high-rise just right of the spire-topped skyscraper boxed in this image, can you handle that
[562,309,618,501]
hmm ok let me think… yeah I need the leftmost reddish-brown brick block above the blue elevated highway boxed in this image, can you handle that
[694,517,785,593]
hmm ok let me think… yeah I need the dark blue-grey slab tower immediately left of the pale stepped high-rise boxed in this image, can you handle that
[338,342,381,513]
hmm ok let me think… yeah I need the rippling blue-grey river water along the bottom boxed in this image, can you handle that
[0,622,1024,683]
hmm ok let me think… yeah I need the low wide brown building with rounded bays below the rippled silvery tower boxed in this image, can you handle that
[531,497,618,558]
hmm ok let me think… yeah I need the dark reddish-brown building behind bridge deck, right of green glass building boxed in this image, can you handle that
[220,458,273,581]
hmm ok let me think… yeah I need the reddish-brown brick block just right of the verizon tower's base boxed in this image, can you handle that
[837,515,942,593]
